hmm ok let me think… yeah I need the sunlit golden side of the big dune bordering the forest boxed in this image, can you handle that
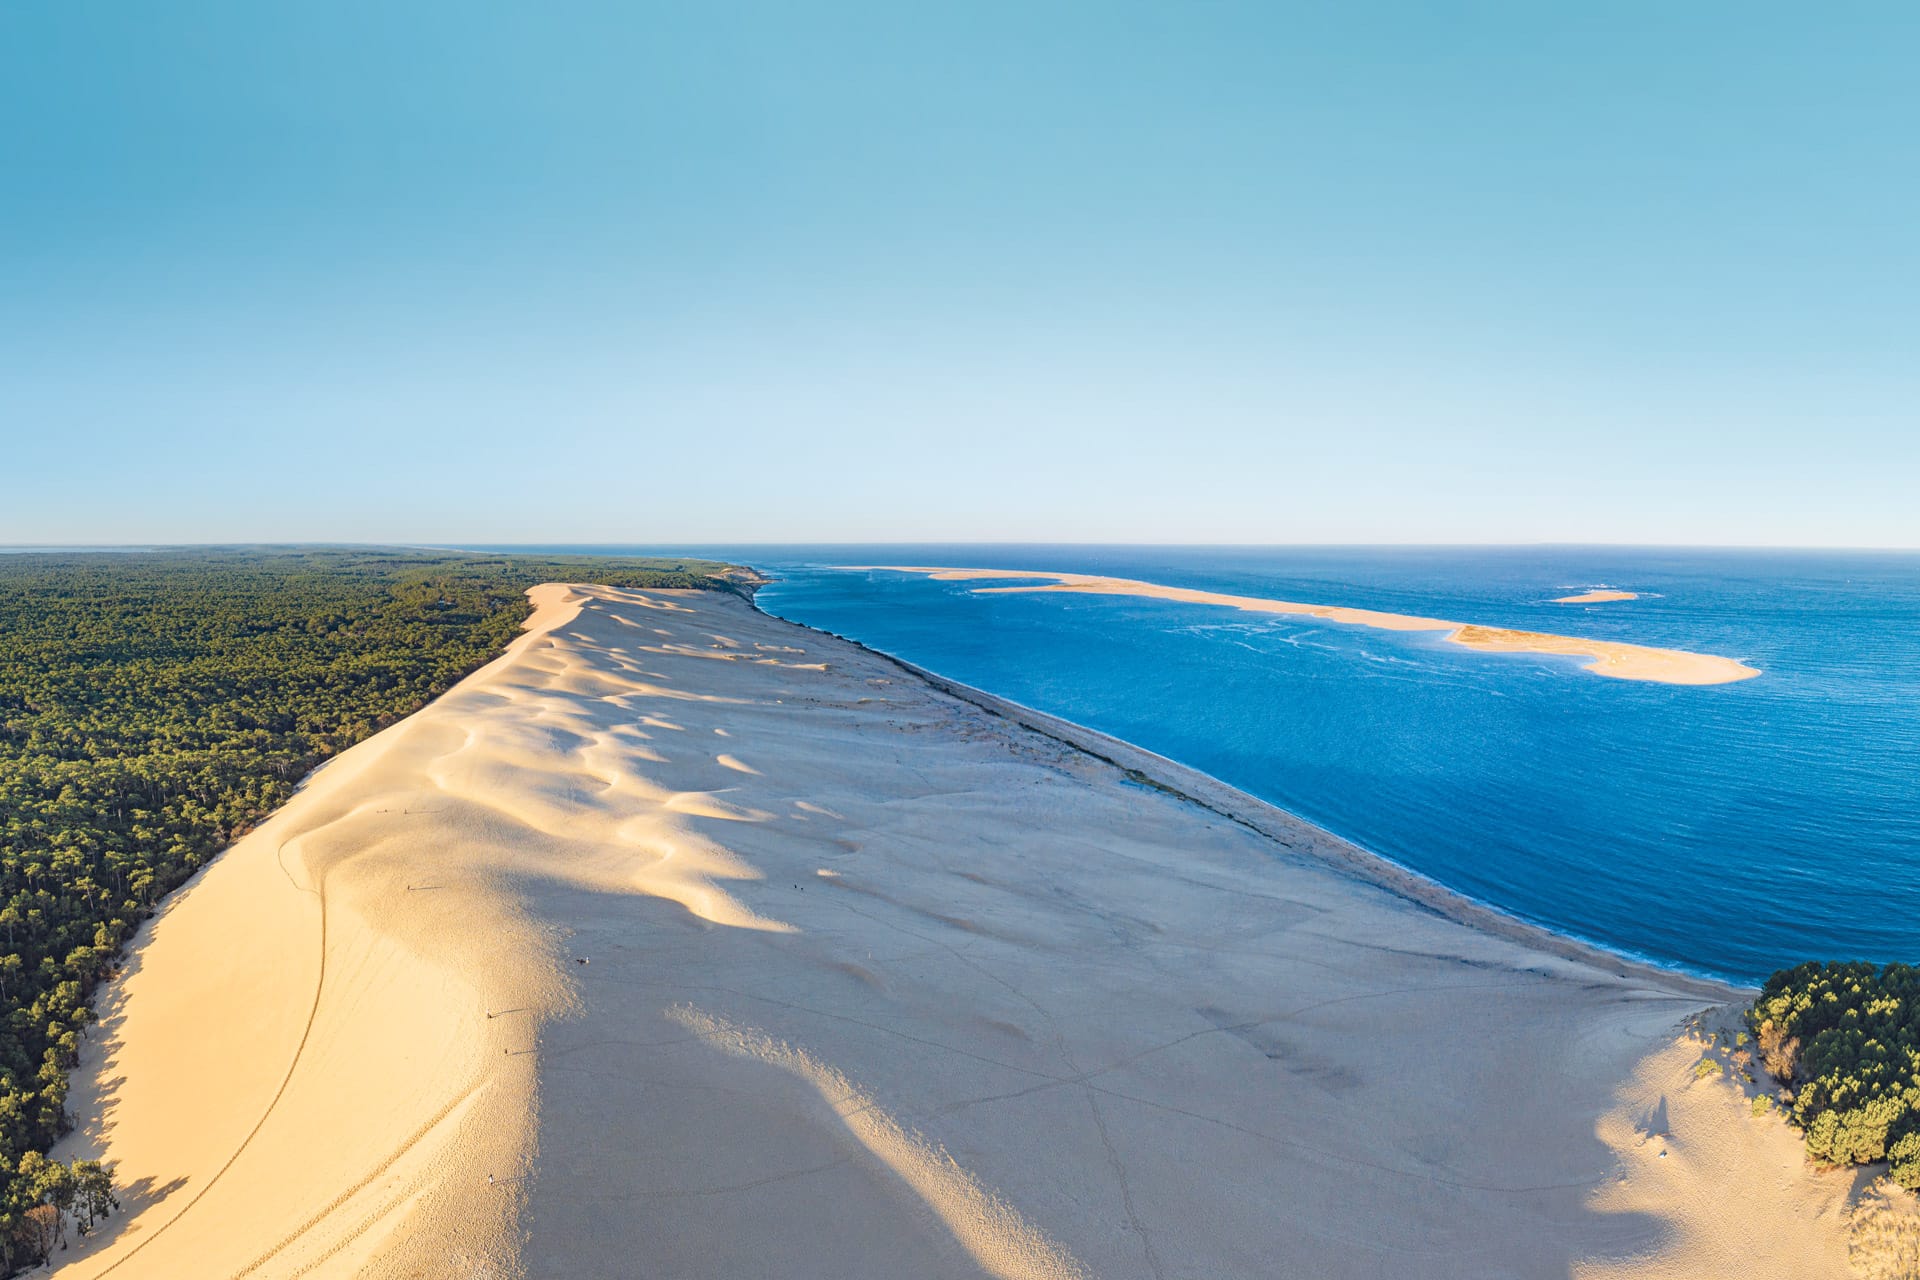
[61,585,791,1280]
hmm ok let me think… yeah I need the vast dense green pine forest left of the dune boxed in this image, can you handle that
[0,549,732,1276]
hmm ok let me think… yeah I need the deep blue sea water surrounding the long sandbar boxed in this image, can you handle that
[472,545,1920,983]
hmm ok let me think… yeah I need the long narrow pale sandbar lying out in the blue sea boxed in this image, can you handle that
[845,564,1761,685]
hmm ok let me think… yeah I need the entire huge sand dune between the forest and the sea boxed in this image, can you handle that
[60,587,1855,1280]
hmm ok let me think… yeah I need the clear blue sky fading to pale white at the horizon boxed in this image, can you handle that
[0,0,1920,547]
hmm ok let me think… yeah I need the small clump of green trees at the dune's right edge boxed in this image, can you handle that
[1747,961,1920,1190]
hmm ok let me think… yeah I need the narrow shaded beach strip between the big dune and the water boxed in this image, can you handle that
[743,580,1759,1004]
